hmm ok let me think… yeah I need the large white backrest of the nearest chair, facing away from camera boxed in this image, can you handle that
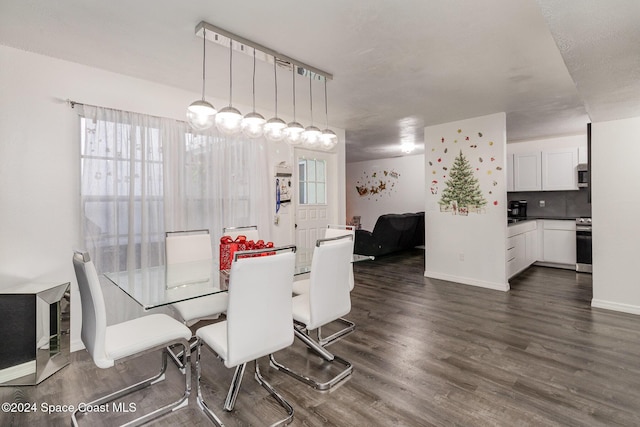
[225,246,296,367]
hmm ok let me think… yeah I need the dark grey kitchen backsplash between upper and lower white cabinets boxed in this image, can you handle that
[507,188,591,218]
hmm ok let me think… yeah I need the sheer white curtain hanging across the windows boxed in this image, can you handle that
[81,105,270,272]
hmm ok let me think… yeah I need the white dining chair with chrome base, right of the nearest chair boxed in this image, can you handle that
[269,235,353,390]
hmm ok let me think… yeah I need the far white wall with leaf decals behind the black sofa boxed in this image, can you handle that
[345,154,425,231]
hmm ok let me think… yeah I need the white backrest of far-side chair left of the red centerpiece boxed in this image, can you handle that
[165,230,213,264]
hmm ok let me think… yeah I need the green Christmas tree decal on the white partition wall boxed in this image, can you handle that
[439,150,487,215]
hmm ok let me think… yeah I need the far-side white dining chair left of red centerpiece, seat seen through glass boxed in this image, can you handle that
[165,230,228,326]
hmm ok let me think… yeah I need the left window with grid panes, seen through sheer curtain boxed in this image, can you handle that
[80,115,164,270]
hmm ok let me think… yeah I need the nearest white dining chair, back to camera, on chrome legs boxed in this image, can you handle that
[196,246,295,426]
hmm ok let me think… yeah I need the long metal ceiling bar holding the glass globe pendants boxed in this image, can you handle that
[195,21,333,80]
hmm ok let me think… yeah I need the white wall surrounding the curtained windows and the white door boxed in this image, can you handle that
[0,46,345,349]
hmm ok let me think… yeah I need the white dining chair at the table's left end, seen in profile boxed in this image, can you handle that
[71,251,191,426]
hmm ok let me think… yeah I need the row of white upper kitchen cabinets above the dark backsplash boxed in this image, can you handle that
[507,135,586,191]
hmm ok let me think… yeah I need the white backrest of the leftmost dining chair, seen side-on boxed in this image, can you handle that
[73,251,114,368]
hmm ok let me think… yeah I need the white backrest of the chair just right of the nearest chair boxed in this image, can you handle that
[306,234,353,329]
